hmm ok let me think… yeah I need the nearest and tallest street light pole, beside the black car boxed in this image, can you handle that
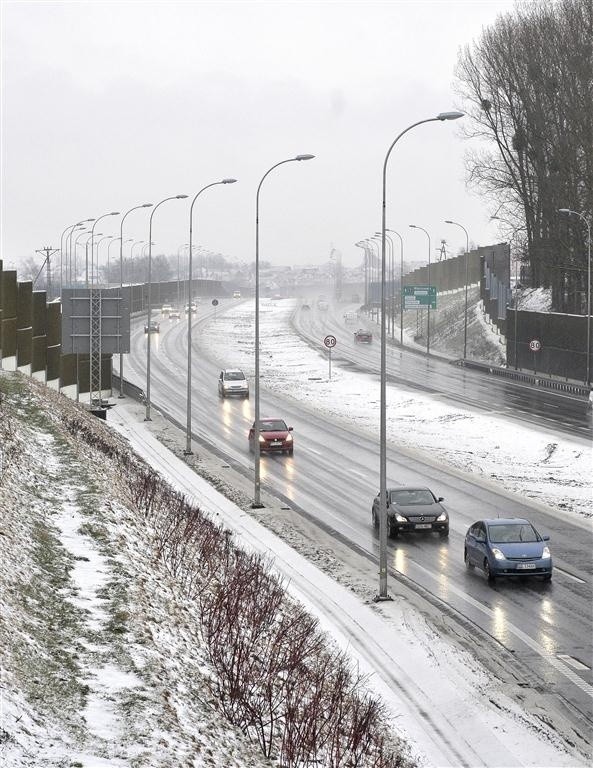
[377,112,463,600]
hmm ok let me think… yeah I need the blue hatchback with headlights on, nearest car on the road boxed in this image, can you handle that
[463,517,552,582]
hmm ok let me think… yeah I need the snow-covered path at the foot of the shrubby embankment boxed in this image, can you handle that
[108,408,583,768]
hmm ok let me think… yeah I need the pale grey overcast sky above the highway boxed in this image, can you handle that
[2,0,513,266]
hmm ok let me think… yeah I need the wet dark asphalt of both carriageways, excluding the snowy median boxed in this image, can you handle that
[125,305,593,748]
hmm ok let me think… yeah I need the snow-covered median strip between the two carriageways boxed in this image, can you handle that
[200,299,593,519]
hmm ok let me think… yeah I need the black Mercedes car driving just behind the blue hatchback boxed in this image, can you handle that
[371,486,449,538]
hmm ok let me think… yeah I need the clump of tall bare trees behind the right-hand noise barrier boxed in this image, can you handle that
[456,0,593,311]
